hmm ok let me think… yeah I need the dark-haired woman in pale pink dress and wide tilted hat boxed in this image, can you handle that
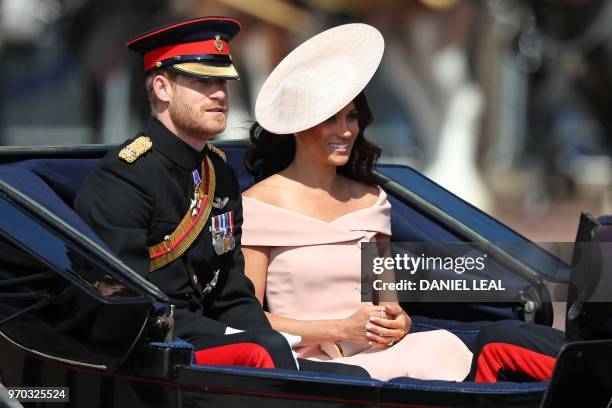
[242,24,472,381]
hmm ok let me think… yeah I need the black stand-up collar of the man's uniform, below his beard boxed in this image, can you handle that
[145,118,208,171]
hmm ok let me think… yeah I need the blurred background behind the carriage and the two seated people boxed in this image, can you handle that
[0,0,612,242]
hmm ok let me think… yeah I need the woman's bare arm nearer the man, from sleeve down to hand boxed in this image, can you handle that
[242,246,384,346]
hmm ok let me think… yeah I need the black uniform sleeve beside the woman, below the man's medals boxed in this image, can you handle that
[208,167,270,330]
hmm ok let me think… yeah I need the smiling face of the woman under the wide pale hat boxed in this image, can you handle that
[295,102,359,166]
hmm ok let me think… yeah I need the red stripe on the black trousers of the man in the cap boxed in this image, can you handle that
[194,343,274,368]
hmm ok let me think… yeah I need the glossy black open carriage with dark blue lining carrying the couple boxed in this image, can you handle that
[0,142,612,408]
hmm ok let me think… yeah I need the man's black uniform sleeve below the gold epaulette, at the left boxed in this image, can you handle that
[74,163,153,277]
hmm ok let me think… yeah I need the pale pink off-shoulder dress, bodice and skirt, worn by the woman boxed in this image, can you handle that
[242,188,472,381]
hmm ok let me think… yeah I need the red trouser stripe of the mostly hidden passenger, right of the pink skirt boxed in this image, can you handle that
[475,343,556,382]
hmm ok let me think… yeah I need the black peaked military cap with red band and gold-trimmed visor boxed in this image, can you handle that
[125,17,242,79]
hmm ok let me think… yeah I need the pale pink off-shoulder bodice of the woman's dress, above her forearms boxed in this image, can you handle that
[242,188,391,319]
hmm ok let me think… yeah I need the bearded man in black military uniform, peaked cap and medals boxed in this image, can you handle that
[75,17,367,376]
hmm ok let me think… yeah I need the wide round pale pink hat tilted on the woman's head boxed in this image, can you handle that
[255,23,385,134]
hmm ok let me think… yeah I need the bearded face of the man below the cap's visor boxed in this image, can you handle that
[168,75,229,140]
